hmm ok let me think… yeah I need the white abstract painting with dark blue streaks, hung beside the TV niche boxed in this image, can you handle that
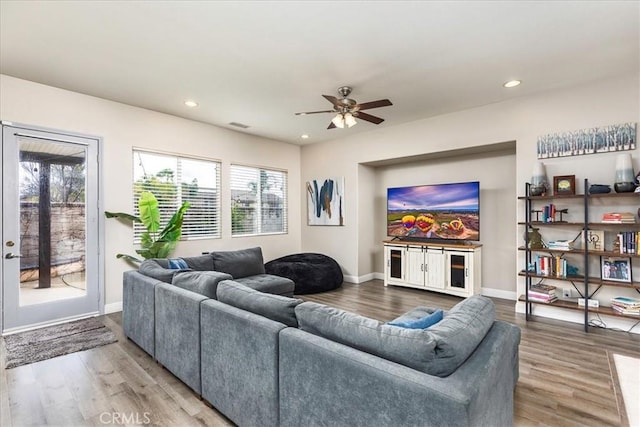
[307,177,344,225]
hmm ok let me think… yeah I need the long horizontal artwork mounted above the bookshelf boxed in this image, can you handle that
[537,123,636,159]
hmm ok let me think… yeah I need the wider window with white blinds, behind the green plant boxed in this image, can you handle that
[133,150,220,242]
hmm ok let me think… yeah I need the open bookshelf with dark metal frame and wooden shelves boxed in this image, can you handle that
[518,179,640,331]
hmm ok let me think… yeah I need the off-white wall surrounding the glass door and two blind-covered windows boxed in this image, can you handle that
[0,75,301,305]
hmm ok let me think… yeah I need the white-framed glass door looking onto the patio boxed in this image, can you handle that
[2,126,100,331]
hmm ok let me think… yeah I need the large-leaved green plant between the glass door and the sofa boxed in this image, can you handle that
[104,191,190,264]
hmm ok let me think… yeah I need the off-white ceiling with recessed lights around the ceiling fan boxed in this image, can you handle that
[0,0,640,144]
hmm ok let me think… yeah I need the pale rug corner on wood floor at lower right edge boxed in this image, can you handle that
[609,353,640,427]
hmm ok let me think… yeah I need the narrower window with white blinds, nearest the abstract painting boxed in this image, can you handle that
[231,165,288,236]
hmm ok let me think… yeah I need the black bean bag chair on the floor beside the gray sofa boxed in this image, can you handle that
[264,253,343,295]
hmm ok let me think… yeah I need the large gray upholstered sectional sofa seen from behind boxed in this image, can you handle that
[123,247,520,427]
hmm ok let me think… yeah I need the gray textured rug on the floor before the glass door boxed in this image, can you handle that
[4,317,118,369]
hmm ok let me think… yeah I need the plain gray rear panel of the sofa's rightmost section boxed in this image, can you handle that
[280,324,519,426]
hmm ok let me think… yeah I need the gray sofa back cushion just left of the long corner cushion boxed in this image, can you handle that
[217,280,302,328]
